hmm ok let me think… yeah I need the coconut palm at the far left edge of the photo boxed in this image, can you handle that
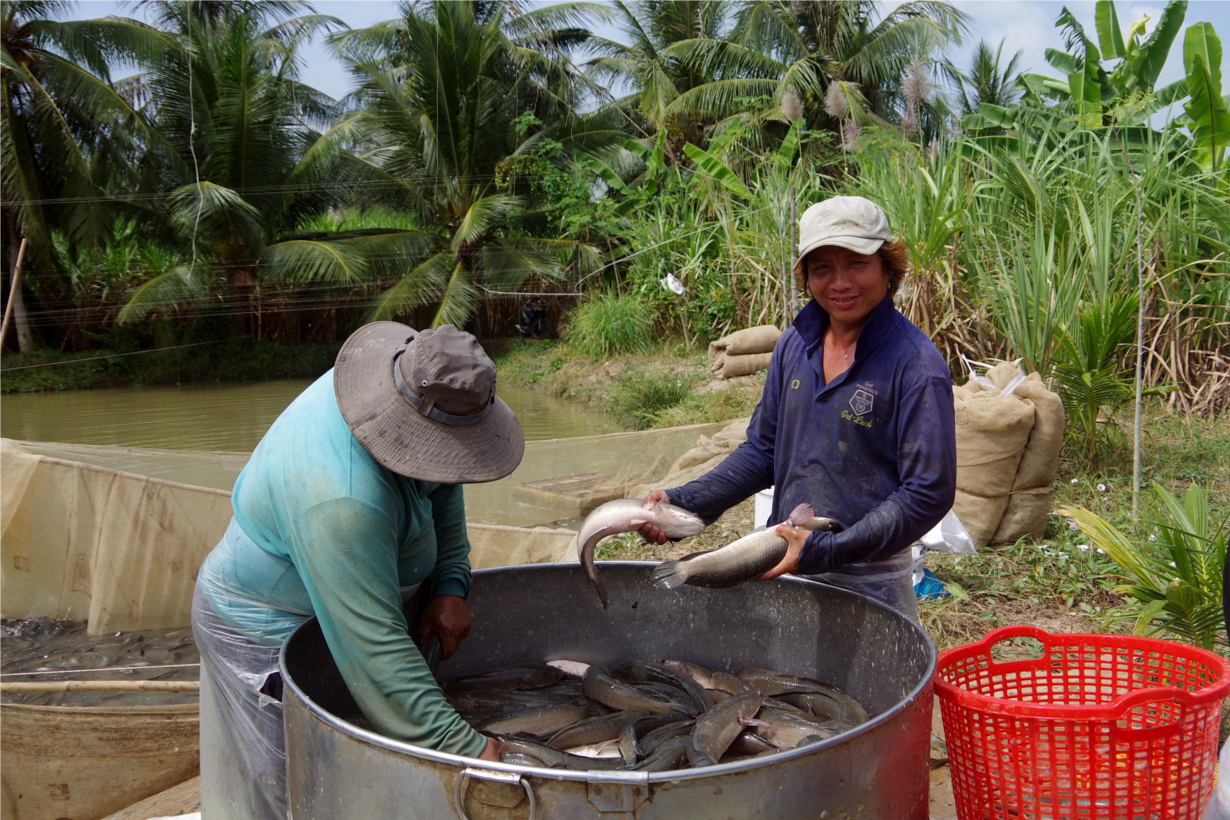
[0,0,158,350]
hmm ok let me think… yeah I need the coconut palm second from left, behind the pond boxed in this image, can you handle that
[114,0,365,322]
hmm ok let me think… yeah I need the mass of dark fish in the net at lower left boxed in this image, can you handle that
[0,618,200,707]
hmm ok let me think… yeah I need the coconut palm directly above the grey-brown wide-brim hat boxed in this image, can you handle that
[326,0,617,327]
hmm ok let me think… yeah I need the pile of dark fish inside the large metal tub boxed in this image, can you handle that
[443,660,867,772]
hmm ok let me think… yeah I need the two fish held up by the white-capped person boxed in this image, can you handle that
[577,498,841,609]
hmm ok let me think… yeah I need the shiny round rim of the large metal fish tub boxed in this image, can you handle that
[278,561,936,786]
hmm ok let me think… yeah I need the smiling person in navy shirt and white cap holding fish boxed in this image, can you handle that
[641,197,957,617]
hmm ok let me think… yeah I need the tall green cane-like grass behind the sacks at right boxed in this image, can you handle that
[850,125,1230,430]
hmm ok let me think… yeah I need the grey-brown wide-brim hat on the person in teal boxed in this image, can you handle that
[333,322,525,484]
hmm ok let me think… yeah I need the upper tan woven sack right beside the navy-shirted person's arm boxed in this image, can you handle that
[952,387,1033,496]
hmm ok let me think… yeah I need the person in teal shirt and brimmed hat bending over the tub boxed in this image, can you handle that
[193,322,524,820]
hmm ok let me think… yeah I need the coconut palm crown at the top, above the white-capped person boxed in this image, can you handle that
[667,0,969,129]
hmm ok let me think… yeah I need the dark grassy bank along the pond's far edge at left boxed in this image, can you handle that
[0,339,341,393]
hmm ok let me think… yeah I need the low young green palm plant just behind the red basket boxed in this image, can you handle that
[1060,482,1230,650]
